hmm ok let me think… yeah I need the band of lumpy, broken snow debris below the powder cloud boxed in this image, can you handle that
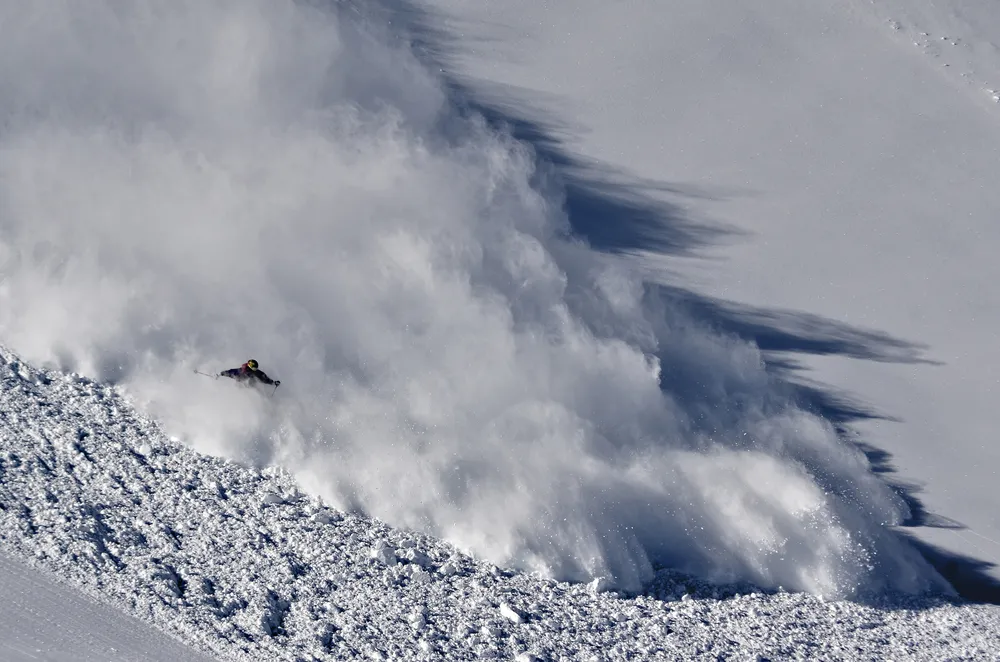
[0,350,1000,662]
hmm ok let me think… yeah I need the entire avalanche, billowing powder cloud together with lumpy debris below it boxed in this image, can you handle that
[0,0,998,661]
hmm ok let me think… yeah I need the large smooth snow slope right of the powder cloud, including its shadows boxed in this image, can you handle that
[420,0,1000,599]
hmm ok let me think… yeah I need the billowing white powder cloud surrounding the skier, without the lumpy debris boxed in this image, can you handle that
[0,0,939,595]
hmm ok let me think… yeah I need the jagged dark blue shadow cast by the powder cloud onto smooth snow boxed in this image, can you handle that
[370,0,1000,604]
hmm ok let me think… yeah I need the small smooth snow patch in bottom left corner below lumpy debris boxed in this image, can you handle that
[0,555,211,662]
